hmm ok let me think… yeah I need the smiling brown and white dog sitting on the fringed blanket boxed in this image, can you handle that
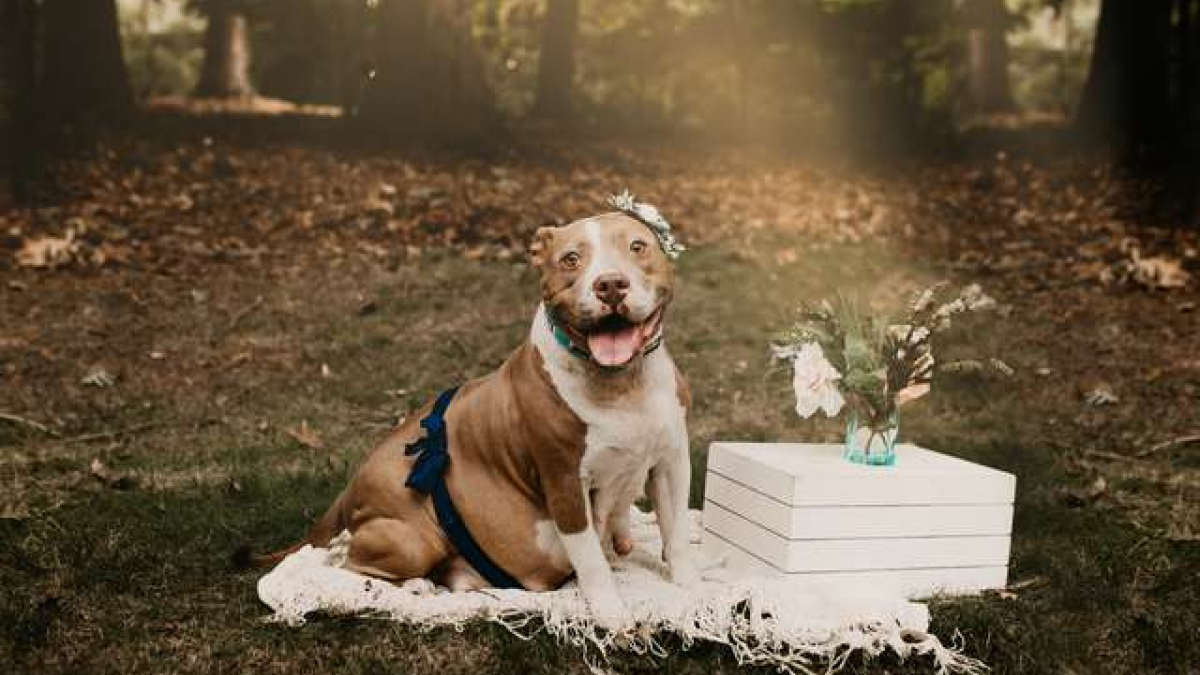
[241,213,698,628]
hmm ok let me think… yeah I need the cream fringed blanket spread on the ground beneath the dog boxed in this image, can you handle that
[258,509,985,673]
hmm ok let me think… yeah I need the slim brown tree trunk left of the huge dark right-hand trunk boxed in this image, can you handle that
[966,0,1016,114]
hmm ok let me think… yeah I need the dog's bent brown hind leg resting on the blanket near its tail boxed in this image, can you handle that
[346,518,450,581]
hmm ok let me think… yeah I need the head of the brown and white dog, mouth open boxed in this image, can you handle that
[532,213,674,368]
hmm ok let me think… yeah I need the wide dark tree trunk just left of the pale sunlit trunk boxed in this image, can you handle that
[41,0,133,120]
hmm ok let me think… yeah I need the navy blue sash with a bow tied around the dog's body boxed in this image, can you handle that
[404,387,524,589]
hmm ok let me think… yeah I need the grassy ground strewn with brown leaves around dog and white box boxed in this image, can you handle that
[0,139,1200,673]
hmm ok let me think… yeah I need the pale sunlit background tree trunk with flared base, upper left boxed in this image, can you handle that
[196,0,254,98]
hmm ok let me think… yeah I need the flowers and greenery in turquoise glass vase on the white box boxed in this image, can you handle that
[774,283,1013,465]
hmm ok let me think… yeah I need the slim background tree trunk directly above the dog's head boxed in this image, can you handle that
[534,0,580,120]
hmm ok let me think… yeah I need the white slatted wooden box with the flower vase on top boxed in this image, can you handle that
[703,442,1016,597]
